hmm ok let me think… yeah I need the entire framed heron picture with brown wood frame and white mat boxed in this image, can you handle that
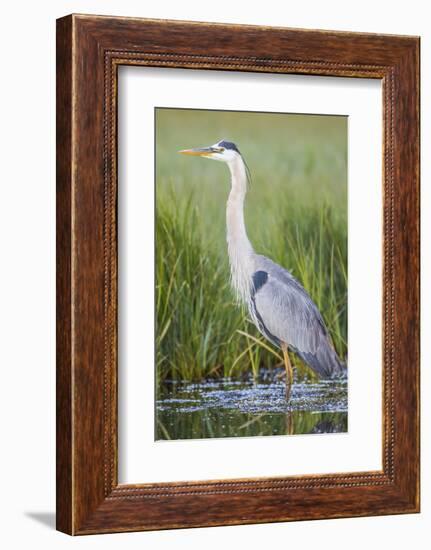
[57,15,419,535]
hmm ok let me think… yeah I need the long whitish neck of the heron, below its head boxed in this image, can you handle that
[226,156,254,303]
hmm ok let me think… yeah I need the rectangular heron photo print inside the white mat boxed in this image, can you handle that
[155,108,348,440]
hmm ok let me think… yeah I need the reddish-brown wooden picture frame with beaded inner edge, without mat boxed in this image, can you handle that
[57,15,419,534]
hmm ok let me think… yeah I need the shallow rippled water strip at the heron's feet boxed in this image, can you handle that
[156,375,347,439]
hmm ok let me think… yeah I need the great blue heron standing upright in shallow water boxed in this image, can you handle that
[180,140,346,399]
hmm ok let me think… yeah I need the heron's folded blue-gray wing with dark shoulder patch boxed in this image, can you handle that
[251,257,343,377]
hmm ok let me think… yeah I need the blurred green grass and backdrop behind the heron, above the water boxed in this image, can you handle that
[155,108,347,387]
